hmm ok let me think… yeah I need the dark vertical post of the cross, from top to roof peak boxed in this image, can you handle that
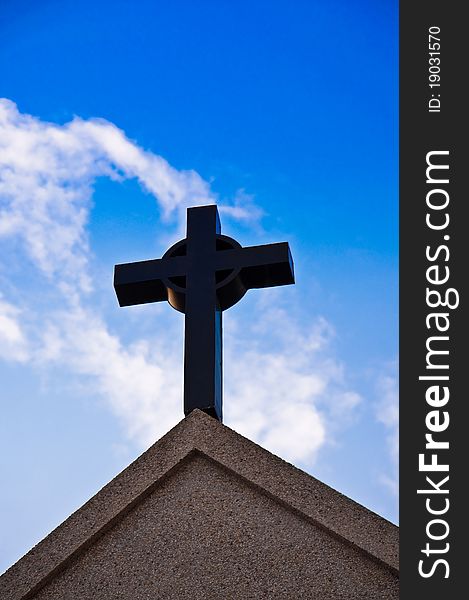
[184,206,222,421]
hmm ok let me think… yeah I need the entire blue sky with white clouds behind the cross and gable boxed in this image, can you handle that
[0,0,398,568]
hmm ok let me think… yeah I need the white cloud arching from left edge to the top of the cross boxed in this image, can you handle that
[0,99,214,291]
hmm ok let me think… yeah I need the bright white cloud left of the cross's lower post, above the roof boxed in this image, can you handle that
[42,309,181,447]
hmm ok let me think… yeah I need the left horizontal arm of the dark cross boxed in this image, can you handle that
[114,256,187,306]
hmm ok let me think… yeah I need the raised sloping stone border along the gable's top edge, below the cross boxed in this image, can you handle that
[0,410,398,600]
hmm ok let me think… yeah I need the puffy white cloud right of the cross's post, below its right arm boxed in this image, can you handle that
[226,304,361,463]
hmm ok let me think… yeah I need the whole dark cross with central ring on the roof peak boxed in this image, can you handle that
[114,205,295,421]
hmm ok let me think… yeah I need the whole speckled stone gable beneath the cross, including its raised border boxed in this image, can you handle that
[0,411,399,600]
